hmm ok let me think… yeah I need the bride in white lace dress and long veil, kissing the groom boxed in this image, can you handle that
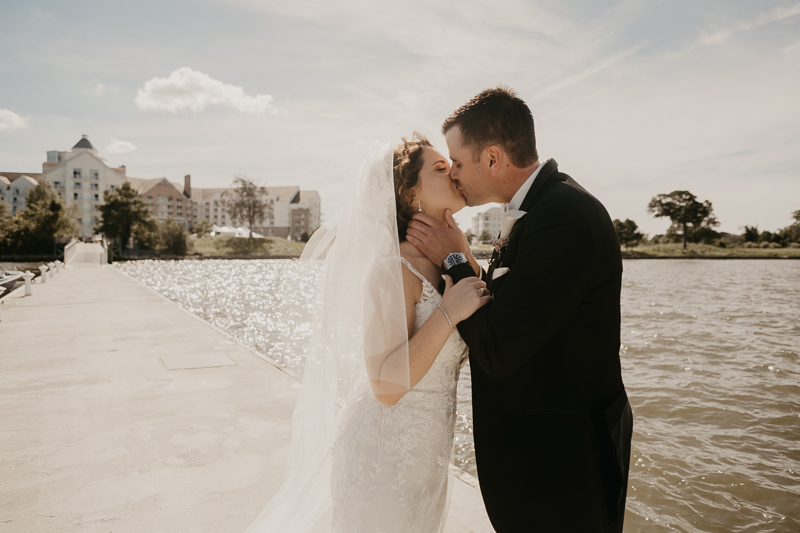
[247,133,490,533]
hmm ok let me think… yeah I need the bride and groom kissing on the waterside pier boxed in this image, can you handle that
[247,87,633,533]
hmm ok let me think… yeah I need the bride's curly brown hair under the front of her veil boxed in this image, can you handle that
[394,131,433,242]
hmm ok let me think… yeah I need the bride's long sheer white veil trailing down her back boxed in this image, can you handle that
[247,143,410,533]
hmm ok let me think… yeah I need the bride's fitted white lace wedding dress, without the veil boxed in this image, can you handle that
[331,259,467,533]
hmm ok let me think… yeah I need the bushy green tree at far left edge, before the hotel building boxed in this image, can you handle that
[6,179,80,253]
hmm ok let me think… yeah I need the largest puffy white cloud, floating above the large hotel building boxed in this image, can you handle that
[134,67,274,114]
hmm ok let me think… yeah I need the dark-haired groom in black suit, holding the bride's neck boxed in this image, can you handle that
[407,88,633,533]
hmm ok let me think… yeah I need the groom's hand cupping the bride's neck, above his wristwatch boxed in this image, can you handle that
[406,209,471,266]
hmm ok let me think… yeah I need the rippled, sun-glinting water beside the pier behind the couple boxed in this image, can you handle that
[117,260,800,532]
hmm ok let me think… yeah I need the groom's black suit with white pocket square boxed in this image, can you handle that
[448,160,633,533]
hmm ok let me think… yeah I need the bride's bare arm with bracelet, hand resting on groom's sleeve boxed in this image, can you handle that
[373,265,490,406]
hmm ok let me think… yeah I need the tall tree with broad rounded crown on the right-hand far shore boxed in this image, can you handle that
[647,191,719,250]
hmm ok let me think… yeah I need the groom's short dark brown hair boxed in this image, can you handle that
[442,86,539,168]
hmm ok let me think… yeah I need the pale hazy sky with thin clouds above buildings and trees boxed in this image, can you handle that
[0,0,800,235]
